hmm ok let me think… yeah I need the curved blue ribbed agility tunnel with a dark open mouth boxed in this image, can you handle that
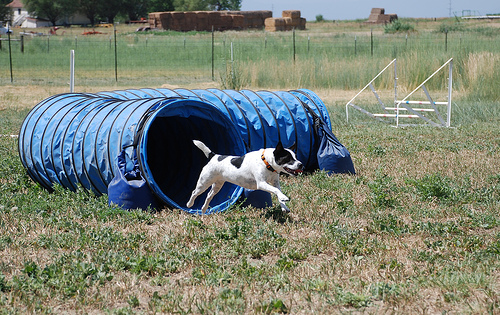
[19,89,354,213]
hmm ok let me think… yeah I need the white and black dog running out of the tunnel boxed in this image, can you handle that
[187,140,304,213]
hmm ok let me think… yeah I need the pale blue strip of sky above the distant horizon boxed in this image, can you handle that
[241,0,500,21]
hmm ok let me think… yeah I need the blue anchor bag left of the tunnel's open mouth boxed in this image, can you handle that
[108,150,158,210]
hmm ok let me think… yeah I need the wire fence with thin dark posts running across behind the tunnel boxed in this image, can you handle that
[0,30,500,88]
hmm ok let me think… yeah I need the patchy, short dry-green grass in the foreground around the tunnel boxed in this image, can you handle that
[0,109,500,313]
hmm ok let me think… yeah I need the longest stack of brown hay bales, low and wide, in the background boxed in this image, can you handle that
[148,11,273,32]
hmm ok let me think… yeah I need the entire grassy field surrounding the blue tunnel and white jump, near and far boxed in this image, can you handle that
[0,21,500,314]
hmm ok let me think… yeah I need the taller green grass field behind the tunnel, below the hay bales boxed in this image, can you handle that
[0,19,500,100]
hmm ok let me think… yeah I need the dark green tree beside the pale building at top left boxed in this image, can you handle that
[24,0,77,26]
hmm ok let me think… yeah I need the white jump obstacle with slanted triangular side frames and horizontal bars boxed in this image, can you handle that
[346,58,453,127]
